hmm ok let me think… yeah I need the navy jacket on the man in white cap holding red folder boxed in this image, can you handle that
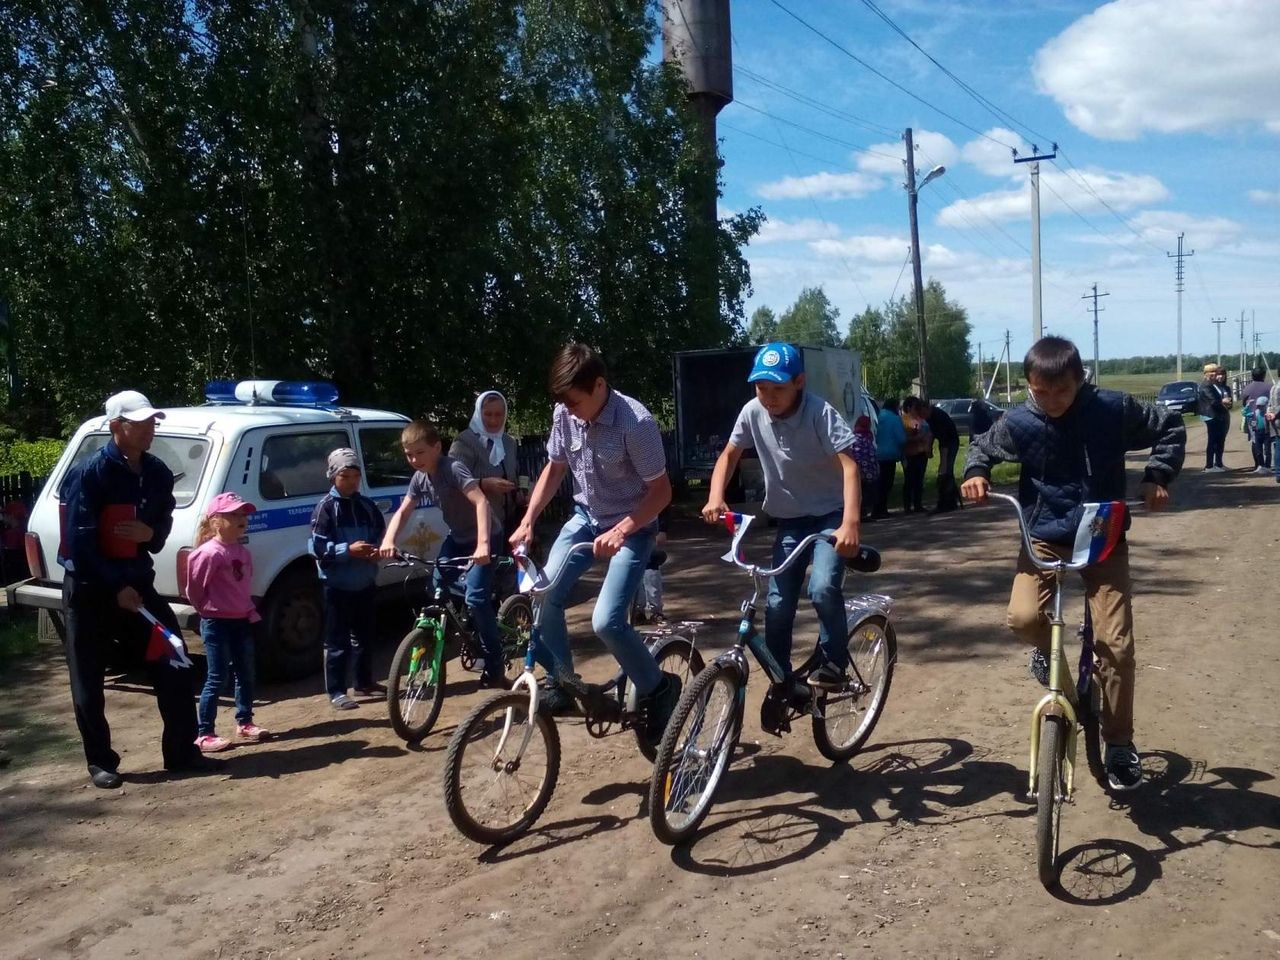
[58,440,174,593]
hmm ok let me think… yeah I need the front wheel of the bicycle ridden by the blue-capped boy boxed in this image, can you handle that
[649,663,742,844]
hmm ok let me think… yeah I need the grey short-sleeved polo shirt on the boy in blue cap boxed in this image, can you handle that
[728,390,854,520]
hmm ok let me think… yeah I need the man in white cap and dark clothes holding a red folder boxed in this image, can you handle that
[58,390,206,790]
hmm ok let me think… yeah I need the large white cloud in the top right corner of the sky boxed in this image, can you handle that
[1033,0,1280,140]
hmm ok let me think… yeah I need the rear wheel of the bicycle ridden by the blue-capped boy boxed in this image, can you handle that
[813,616,897,763]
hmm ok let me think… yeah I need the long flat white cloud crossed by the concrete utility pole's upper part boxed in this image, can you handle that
[938,168,1169,227]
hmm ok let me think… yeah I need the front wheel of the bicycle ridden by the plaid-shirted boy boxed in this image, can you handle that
[444,689,559,844]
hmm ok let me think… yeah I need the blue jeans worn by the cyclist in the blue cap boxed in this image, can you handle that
[764,511,849,673]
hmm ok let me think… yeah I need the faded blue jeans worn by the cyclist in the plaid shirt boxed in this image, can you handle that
[538,507,662,695]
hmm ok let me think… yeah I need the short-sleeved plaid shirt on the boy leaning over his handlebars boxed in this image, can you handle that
[547,389,667,527]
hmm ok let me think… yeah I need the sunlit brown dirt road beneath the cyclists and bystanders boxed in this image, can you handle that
[0,431,1280,960]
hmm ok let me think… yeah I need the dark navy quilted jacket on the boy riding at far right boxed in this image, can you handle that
[964,384,1187,544]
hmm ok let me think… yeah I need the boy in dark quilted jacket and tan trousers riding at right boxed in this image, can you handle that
[960,337,1187,790]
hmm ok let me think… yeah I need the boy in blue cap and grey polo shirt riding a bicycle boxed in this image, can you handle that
[703,343,861,687]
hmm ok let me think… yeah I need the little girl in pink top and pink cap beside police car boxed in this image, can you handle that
[187,493,266,754]
